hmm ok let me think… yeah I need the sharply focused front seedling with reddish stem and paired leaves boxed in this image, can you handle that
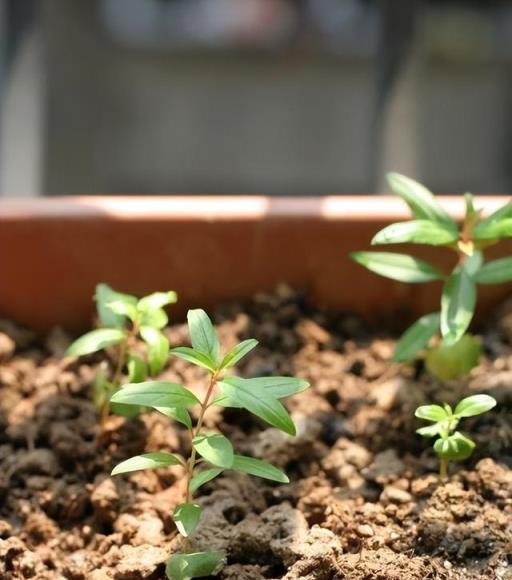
[111,310,309,580]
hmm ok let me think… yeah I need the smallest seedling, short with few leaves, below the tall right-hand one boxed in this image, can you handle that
[415,395,496,480]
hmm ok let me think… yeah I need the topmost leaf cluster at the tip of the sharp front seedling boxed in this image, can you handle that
[171,309,258,373]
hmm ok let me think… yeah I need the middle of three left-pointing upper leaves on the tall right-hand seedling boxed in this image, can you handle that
[372,220,458,246]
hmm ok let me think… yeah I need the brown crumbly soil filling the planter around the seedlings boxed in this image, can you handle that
[0,286,512,580]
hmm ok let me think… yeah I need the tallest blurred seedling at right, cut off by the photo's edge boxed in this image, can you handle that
[352,173,512,380]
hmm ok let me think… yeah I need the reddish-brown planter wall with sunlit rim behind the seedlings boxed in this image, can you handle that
[0,196,512,331]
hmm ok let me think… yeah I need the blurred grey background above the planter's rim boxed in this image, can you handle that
[0,0,512,196]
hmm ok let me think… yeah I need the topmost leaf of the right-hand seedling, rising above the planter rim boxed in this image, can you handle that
[387,173,456,228]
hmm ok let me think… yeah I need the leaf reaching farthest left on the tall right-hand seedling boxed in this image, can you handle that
[350,252,444,284]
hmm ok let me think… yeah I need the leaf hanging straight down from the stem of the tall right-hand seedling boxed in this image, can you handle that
[441,268,476,345]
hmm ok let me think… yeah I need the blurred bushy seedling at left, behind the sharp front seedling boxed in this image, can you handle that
[66,284,177,423]
